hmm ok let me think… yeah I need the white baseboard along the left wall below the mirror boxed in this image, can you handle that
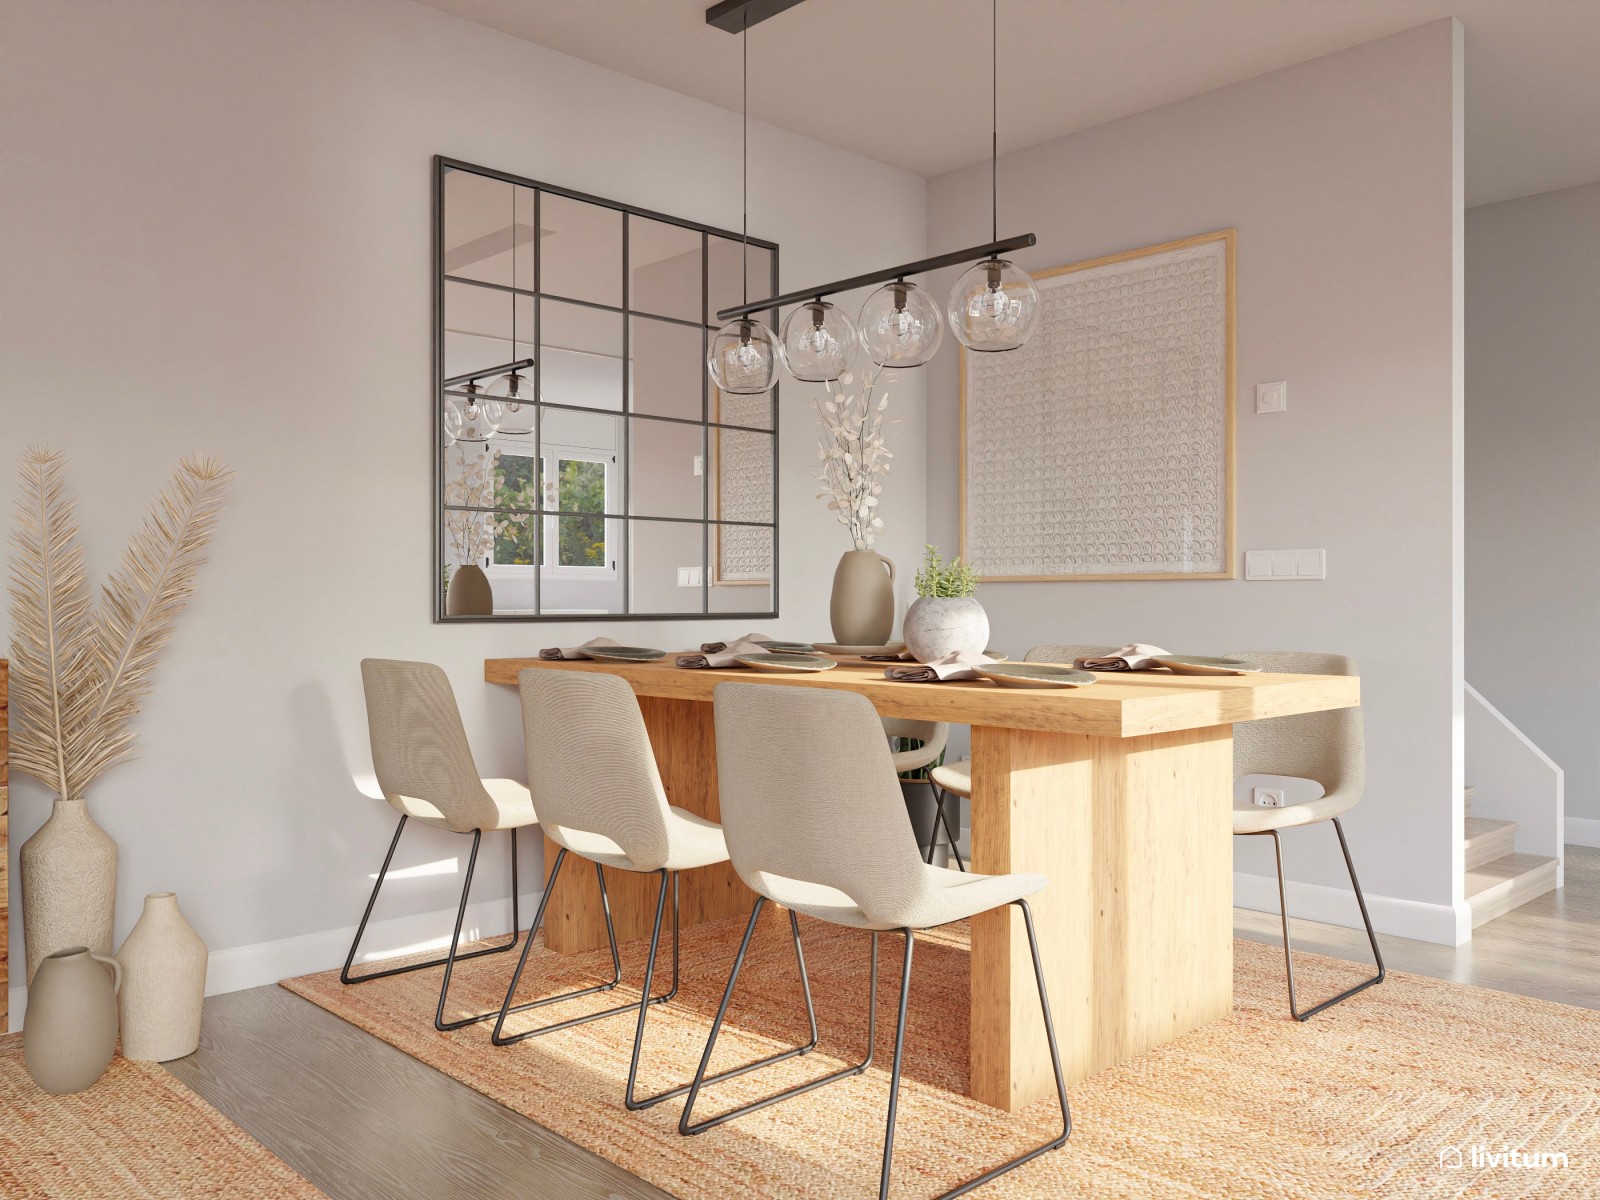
[8,891,541,1030]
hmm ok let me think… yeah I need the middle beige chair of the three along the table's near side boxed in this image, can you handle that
[491,669,732,1109]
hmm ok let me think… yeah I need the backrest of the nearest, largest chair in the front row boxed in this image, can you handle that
[714,683,930,923]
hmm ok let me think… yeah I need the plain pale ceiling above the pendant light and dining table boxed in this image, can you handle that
[421,0,1600,205]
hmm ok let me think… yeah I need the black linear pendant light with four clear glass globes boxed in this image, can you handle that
[706,0,1040,394]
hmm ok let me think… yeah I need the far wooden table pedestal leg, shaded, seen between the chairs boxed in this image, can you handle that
[544,696,755,954]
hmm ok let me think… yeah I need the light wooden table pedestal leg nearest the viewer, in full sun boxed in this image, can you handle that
[971,725,1234,1112]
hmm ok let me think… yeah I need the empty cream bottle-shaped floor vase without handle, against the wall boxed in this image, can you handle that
[117,891,208,1062]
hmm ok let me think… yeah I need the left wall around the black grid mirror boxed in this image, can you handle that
[0,0,925,1017]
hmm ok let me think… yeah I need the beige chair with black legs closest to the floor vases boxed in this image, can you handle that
[339,658,536,1029]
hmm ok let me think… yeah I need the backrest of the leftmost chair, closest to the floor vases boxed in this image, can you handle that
[362,658,499,832]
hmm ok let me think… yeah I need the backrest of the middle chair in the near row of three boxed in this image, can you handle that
[517,667,669,870]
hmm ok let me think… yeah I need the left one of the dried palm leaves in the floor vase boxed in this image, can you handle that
[10,446,99,798]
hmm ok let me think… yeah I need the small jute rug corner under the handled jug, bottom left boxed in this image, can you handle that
[0,1034,322,1200]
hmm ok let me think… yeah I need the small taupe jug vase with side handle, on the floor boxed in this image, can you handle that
[22,946,122,1096]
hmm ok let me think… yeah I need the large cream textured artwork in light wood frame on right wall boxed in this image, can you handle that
[962,230,1234,581]
